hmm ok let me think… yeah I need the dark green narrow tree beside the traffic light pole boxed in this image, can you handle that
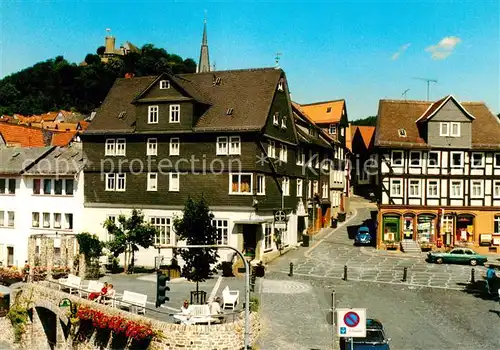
[174,196,219,292]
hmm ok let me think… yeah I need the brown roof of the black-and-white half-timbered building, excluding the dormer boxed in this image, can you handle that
[375,100,500,149]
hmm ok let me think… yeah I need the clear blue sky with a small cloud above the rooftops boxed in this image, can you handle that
[0,0,500,119]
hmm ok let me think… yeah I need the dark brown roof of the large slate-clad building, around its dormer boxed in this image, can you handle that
[87,68,283,133]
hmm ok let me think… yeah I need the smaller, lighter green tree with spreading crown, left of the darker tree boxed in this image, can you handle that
[104,209,157,272]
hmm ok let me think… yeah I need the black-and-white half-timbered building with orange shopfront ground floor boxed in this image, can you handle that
[375,95,500,252]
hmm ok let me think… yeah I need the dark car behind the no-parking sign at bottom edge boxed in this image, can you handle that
[340,318,391,350]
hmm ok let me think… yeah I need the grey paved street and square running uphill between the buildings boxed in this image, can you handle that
[259,198,500,350]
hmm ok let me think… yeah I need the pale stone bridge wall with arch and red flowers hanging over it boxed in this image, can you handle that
[0,281,261,350]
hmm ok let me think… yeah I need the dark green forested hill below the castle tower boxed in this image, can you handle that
[0,44,196,115]
